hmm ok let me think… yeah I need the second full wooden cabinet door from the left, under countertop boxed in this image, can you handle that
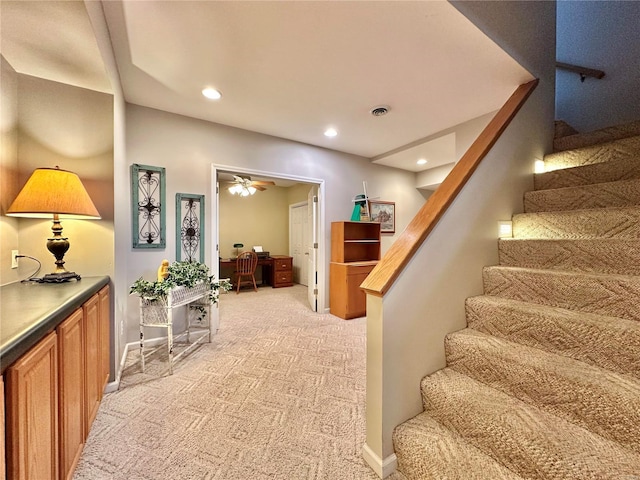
[57,309,86,479]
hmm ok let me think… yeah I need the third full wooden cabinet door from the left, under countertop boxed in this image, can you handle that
[82,294,102,436]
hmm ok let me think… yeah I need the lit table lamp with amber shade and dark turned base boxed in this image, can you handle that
[7,167,100,283]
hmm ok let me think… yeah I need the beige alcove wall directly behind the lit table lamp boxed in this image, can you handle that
[11,75,114,278]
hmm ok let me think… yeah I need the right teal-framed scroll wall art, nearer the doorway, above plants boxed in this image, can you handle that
[176,193,204,263]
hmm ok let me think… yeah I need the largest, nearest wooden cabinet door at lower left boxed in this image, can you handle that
[6,332,58,480]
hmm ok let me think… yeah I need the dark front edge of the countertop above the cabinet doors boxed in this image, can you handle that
[0,276,111,374]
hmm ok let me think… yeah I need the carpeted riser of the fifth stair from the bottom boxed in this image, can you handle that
[482,266,640,321]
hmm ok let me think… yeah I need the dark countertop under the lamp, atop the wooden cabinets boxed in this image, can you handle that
[0,276,109,373]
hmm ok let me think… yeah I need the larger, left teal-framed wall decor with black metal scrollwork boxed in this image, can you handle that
[131,163,167,248]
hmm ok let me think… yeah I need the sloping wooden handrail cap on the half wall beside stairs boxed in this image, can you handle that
[360,79,538,297]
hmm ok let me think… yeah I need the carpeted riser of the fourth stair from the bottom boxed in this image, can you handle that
[465,295,640,380]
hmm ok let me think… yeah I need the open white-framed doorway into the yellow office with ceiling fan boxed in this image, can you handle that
[209,165,325,311]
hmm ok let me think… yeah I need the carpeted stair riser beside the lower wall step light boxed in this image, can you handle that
[512,206,640,239]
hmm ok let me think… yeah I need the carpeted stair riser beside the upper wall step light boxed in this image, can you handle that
[544,135,640,170]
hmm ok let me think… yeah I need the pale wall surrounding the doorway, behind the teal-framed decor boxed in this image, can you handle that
[121,105,424,341]
